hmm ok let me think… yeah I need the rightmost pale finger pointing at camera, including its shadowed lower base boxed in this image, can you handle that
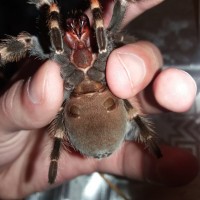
[139,68,197,113]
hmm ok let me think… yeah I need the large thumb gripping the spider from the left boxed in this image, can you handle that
[0,61,63,132]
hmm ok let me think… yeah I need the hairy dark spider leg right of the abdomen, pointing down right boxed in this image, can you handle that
[124,100,162,158]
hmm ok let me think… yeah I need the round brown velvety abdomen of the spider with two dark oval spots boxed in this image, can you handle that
[65,89,127,158]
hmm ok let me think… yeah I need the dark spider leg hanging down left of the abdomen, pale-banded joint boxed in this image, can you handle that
[48,102,66,184]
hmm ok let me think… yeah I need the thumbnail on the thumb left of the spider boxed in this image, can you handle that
[27,76,46,104]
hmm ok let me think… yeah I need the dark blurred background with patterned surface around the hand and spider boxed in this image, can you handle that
[0,0,200,200]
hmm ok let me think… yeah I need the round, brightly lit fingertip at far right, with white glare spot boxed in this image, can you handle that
[153,68,197,112]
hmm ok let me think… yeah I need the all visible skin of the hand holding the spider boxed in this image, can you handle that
[0,0,198,199]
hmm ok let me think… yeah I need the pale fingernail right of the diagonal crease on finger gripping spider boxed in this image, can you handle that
[117,52,146,90]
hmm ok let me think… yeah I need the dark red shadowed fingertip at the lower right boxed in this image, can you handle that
[144,148,198,186]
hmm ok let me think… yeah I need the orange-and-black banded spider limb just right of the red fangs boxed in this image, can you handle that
[90,0,107,54]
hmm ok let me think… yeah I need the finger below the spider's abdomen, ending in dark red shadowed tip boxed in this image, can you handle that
[98,143,198,186]
